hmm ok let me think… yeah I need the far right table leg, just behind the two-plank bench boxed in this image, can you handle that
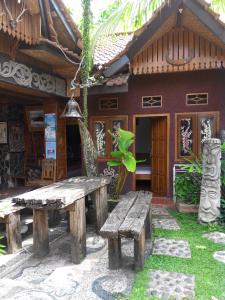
[94,185,108,233]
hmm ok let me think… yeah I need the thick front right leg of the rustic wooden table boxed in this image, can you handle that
[69,198,86,264]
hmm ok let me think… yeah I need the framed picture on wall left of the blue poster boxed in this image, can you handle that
[26,107,45,131]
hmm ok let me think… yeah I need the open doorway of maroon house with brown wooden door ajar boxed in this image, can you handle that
[134,115,169,197]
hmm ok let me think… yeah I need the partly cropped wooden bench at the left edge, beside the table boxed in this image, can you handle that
[0,198,24,254]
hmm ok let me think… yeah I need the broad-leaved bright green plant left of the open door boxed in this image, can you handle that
[107,128,143,198]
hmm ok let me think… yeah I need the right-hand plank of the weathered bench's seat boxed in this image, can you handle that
[119,192,152,238]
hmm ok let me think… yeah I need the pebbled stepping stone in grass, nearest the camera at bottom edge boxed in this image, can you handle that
[147,270,195,300]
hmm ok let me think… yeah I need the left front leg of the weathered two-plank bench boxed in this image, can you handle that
[108,238,121,270]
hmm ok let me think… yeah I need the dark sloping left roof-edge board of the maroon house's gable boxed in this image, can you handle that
[103,0,183,77]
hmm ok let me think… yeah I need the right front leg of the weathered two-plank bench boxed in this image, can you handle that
[134,228,145,271]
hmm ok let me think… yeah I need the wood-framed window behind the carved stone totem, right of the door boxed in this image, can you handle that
[175,112,219,160]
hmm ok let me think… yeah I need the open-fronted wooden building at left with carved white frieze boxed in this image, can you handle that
[0,0,82,188]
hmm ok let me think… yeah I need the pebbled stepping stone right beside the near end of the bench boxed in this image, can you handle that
[153,238,191,258]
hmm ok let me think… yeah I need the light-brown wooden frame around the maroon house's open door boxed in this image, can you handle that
[132,113,170,195]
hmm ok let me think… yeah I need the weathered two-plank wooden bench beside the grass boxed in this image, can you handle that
[100,191,152,270]
